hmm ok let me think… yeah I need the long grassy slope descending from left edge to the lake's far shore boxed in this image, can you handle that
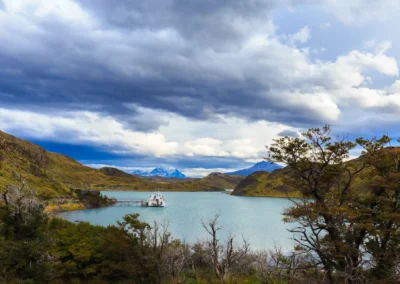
[0,131,241,198]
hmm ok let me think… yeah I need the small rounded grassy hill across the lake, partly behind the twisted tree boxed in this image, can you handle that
[232,169,300,197]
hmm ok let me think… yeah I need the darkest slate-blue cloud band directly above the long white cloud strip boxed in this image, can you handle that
[0,61,324,130]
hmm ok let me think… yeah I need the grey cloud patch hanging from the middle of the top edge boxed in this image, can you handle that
[79,0,278,47]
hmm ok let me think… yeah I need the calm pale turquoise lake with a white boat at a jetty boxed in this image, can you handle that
[59,191,294,250]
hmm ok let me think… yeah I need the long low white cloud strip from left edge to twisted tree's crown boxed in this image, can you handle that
[0,108,294,159]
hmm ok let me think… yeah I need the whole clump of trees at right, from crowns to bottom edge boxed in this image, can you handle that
[269,126,400,283]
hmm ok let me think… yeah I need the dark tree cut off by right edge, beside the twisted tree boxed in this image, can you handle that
[356,135,400,282]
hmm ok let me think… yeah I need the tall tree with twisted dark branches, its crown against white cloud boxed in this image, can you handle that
[269,125,367,283]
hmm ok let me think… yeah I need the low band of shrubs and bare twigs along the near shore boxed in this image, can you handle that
[0,182,305,283]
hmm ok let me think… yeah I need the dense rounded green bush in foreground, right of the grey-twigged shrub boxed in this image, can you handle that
[51,219,140,281]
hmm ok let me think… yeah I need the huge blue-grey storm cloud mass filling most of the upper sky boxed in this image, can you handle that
[0,0,340,130]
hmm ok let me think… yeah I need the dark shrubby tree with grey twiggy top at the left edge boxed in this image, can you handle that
[0,176,54,283]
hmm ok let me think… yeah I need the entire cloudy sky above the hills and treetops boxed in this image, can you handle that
[0,0,400,176]
